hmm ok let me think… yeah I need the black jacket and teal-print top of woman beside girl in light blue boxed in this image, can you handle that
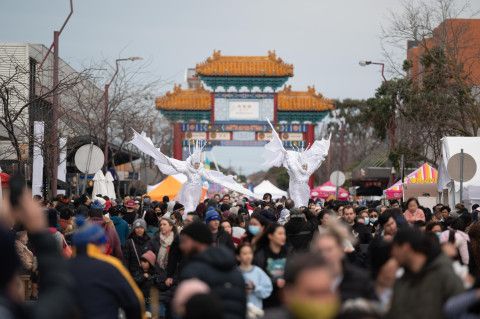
[253,246,288,308]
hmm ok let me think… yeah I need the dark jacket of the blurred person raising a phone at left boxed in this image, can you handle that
[0,227,75,319]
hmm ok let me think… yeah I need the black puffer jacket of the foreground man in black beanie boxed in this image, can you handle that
[180,246,247,319]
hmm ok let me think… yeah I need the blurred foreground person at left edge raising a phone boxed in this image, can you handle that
[0,176,74,319]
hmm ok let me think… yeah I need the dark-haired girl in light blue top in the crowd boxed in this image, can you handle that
[237,243,273,309]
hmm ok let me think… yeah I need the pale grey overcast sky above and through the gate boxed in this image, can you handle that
[0,0,480,172]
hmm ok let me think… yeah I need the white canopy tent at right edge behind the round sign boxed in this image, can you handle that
[438,136,480,207]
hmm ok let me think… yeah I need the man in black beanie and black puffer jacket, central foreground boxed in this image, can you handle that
[180,222,247,319]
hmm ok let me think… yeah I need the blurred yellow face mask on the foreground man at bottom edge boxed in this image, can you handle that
[288,300,339,319]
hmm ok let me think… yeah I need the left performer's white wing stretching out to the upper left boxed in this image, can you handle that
[130,130,187,175]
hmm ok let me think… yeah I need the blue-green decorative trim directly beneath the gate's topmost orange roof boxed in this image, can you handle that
[200,76,288,91]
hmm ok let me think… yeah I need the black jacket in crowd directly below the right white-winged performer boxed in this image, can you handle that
[285,215,318,252]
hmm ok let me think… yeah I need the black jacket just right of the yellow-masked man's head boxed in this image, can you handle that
[338,262,377,301]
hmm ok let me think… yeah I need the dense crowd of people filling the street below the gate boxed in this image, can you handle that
[0,194,480,319]
